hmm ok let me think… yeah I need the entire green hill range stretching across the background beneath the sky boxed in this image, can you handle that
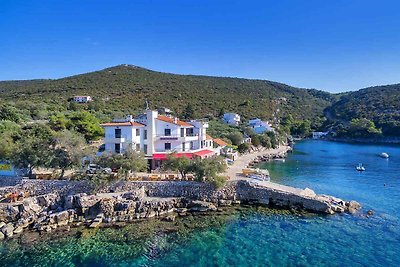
[0,64,400,136]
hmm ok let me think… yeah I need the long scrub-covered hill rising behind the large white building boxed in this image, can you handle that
[0,65,335,121]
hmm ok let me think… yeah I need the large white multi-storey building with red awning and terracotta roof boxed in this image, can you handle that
[102,110,215,169]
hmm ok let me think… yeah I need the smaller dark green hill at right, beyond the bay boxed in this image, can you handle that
[326,84,400,136]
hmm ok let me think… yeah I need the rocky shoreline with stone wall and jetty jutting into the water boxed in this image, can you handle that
[0,180,361,239]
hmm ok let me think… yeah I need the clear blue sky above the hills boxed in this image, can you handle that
[0,0,400,92]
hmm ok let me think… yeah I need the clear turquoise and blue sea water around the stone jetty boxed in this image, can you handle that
[0,141,400,266]
